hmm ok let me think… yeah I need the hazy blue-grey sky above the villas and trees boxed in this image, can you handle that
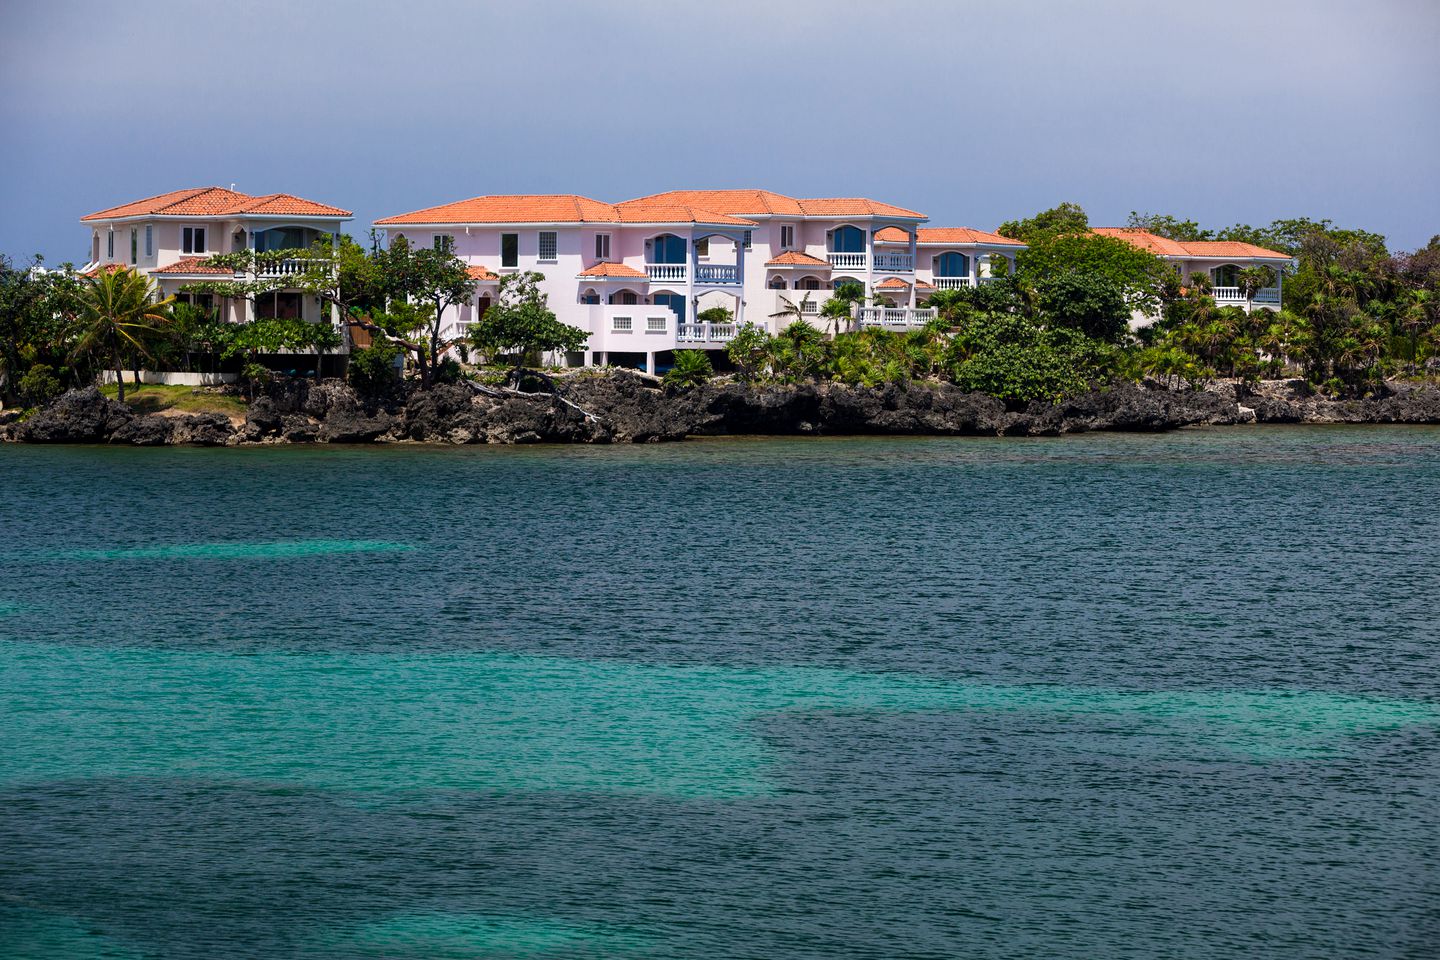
[0,0,1440,265]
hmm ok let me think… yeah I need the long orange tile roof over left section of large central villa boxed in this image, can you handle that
[376,193,755,226]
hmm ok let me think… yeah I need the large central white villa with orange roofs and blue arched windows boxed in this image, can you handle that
[374,190,1024,371]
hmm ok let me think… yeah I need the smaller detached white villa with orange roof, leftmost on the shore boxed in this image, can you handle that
[81,187,351,331]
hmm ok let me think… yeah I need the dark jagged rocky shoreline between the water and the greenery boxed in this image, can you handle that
[0,371,1440,446]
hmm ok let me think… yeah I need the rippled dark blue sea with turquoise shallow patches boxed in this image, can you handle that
[0,427,1440,960]
